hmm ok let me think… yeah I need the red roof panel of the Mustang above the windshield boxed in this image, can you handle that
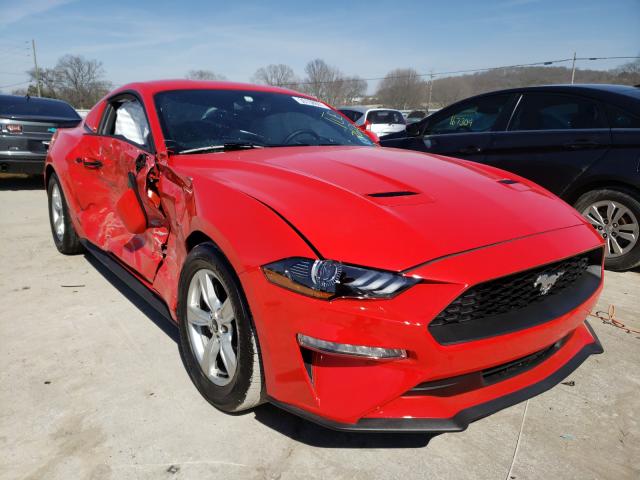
[110,79,312,98]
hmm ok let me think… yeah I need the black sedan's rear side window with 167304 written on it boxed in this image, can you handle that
[509,93,607,130]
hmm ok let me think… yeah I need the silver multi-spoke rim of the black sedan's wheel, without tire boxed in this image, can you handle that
[582,200,639,258]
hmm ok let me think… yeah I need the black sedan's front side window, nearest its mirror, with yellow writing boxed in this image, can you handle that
[425,95,511,134]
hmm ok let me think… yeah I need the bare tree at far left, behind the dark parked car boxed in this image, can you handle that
[26,55,111,108]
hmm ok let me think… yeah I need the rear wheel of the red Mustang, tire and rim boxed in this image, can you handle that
[47,173,84,255]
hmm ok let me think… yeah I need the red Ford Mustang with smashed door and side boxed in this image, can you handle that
[45,81,603,432]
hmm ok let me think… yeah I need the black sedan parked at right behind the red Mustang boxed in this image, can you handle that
[381,85,640,270]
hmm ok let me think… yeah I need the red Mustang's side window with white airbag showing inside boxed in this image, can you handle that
[102,98,150,147]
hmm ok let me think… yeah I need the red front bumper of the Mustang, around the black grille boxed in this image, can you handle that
[240,225,602,432]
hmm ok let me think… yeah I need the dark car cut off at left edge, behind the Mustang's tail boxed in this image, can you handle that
[0,95,80,174]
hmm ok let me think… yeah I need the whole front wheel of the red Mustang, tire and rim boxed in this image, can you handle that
[178,243,264,413]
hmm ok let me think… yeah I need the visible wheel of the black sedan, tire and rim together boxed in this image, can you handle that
[574,189,640,271]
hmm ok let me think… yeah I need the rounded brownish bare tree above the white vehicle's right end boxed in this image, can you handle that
[376,68,427,109]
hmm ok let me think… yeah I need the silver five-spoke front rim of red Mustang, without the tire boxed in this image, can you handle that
[187,269,238,386]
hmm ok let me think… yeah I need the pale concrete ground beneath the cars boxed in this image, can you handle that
[0,173,640,480]
